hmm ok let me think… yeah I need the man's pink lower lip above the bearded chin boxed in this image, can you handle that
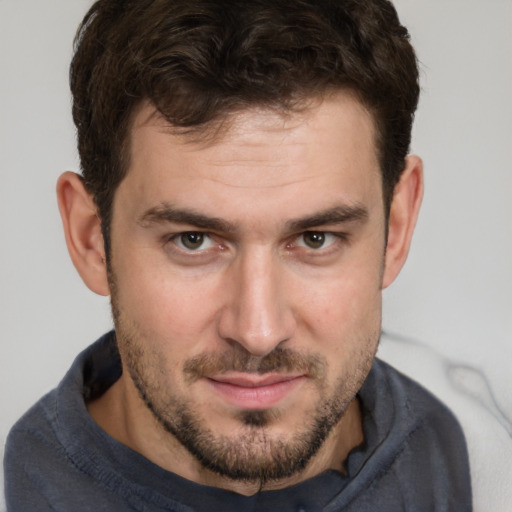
[208,376,305,410]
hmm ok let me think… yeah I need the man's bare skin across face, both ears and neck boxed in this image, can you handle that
[58,93,423,495]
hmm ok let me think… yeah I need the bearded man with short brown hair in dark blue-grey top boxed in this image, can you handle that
[5,0,471,511]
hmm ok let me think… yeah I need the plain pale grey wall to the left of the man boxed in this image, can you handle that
[0,0,110,452]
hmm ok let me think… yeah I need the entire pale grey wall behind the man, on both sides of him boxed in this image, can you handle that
[0,0,512,498]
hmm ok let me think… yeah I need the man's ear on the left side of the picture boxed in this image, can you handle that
[57,172,110,295]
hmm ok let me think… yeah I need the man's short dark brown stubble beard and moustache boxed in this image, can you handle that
[111,276,376,488]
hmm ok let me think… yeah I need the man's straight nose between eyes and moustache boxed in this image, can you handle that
[218,247,296,357]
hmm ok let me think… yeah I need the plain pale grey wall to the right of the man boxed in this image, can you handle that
[384,0,512,400]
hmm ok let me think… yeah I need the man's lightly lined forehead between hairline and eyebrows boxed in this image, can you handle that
[119,93,381,224]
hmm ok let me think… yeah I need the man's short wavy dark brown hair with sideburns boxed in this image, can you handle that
[70,0,419,243]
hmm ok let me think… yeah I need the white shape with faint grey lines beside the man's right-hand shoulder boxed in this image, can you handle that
[379,333,512,512]
